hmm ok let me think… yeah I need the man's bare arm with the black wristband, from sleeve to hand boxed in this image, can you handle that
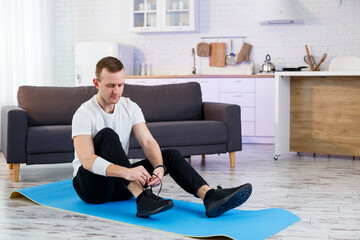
[132,122,165,186]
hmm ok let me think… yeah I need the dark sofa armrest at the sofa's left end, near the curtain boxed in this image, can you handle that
[1,106,28,163]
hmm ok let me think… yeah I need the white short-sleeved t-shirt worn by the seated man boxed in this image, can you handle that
[72,95,145,176]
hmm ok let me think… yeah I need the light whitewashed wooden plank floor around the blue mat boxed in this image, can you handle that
[0,144,360,240]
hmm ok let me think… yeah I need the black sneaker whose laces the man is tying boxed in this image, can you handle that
[136,189,174,218]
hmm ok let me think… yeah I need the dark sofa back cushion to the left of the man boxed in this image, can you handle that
[17,86,97,126]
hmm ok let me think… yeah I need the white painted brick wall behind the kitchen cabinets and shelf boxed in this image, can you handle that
[56,0,360,86]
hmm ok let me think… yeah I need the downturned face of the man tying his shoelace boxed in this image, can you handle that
[94,68,125,104]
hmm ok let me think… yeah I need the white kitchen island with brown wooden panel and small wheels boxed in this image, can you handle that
[274,71,360,160]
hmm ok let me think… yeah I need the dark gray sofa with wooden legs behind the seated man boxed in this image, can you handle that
[1,82,242,181]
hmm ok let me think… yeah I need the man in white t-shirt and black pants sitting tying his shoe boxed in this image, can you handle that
[72,57,252,217]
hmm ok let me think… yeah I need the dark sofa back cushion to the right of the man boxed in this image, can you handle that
[123,82,202,122]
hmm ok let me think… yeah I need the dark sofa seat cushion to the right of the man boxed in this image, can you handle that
[130,120,228,148]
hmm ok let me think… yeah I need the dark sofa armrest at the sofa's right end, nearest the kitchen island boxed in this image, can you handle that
[203,102,242,152]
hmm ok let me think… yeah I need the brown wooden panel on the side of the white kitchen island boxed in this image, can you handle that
[290,76,360,156]
